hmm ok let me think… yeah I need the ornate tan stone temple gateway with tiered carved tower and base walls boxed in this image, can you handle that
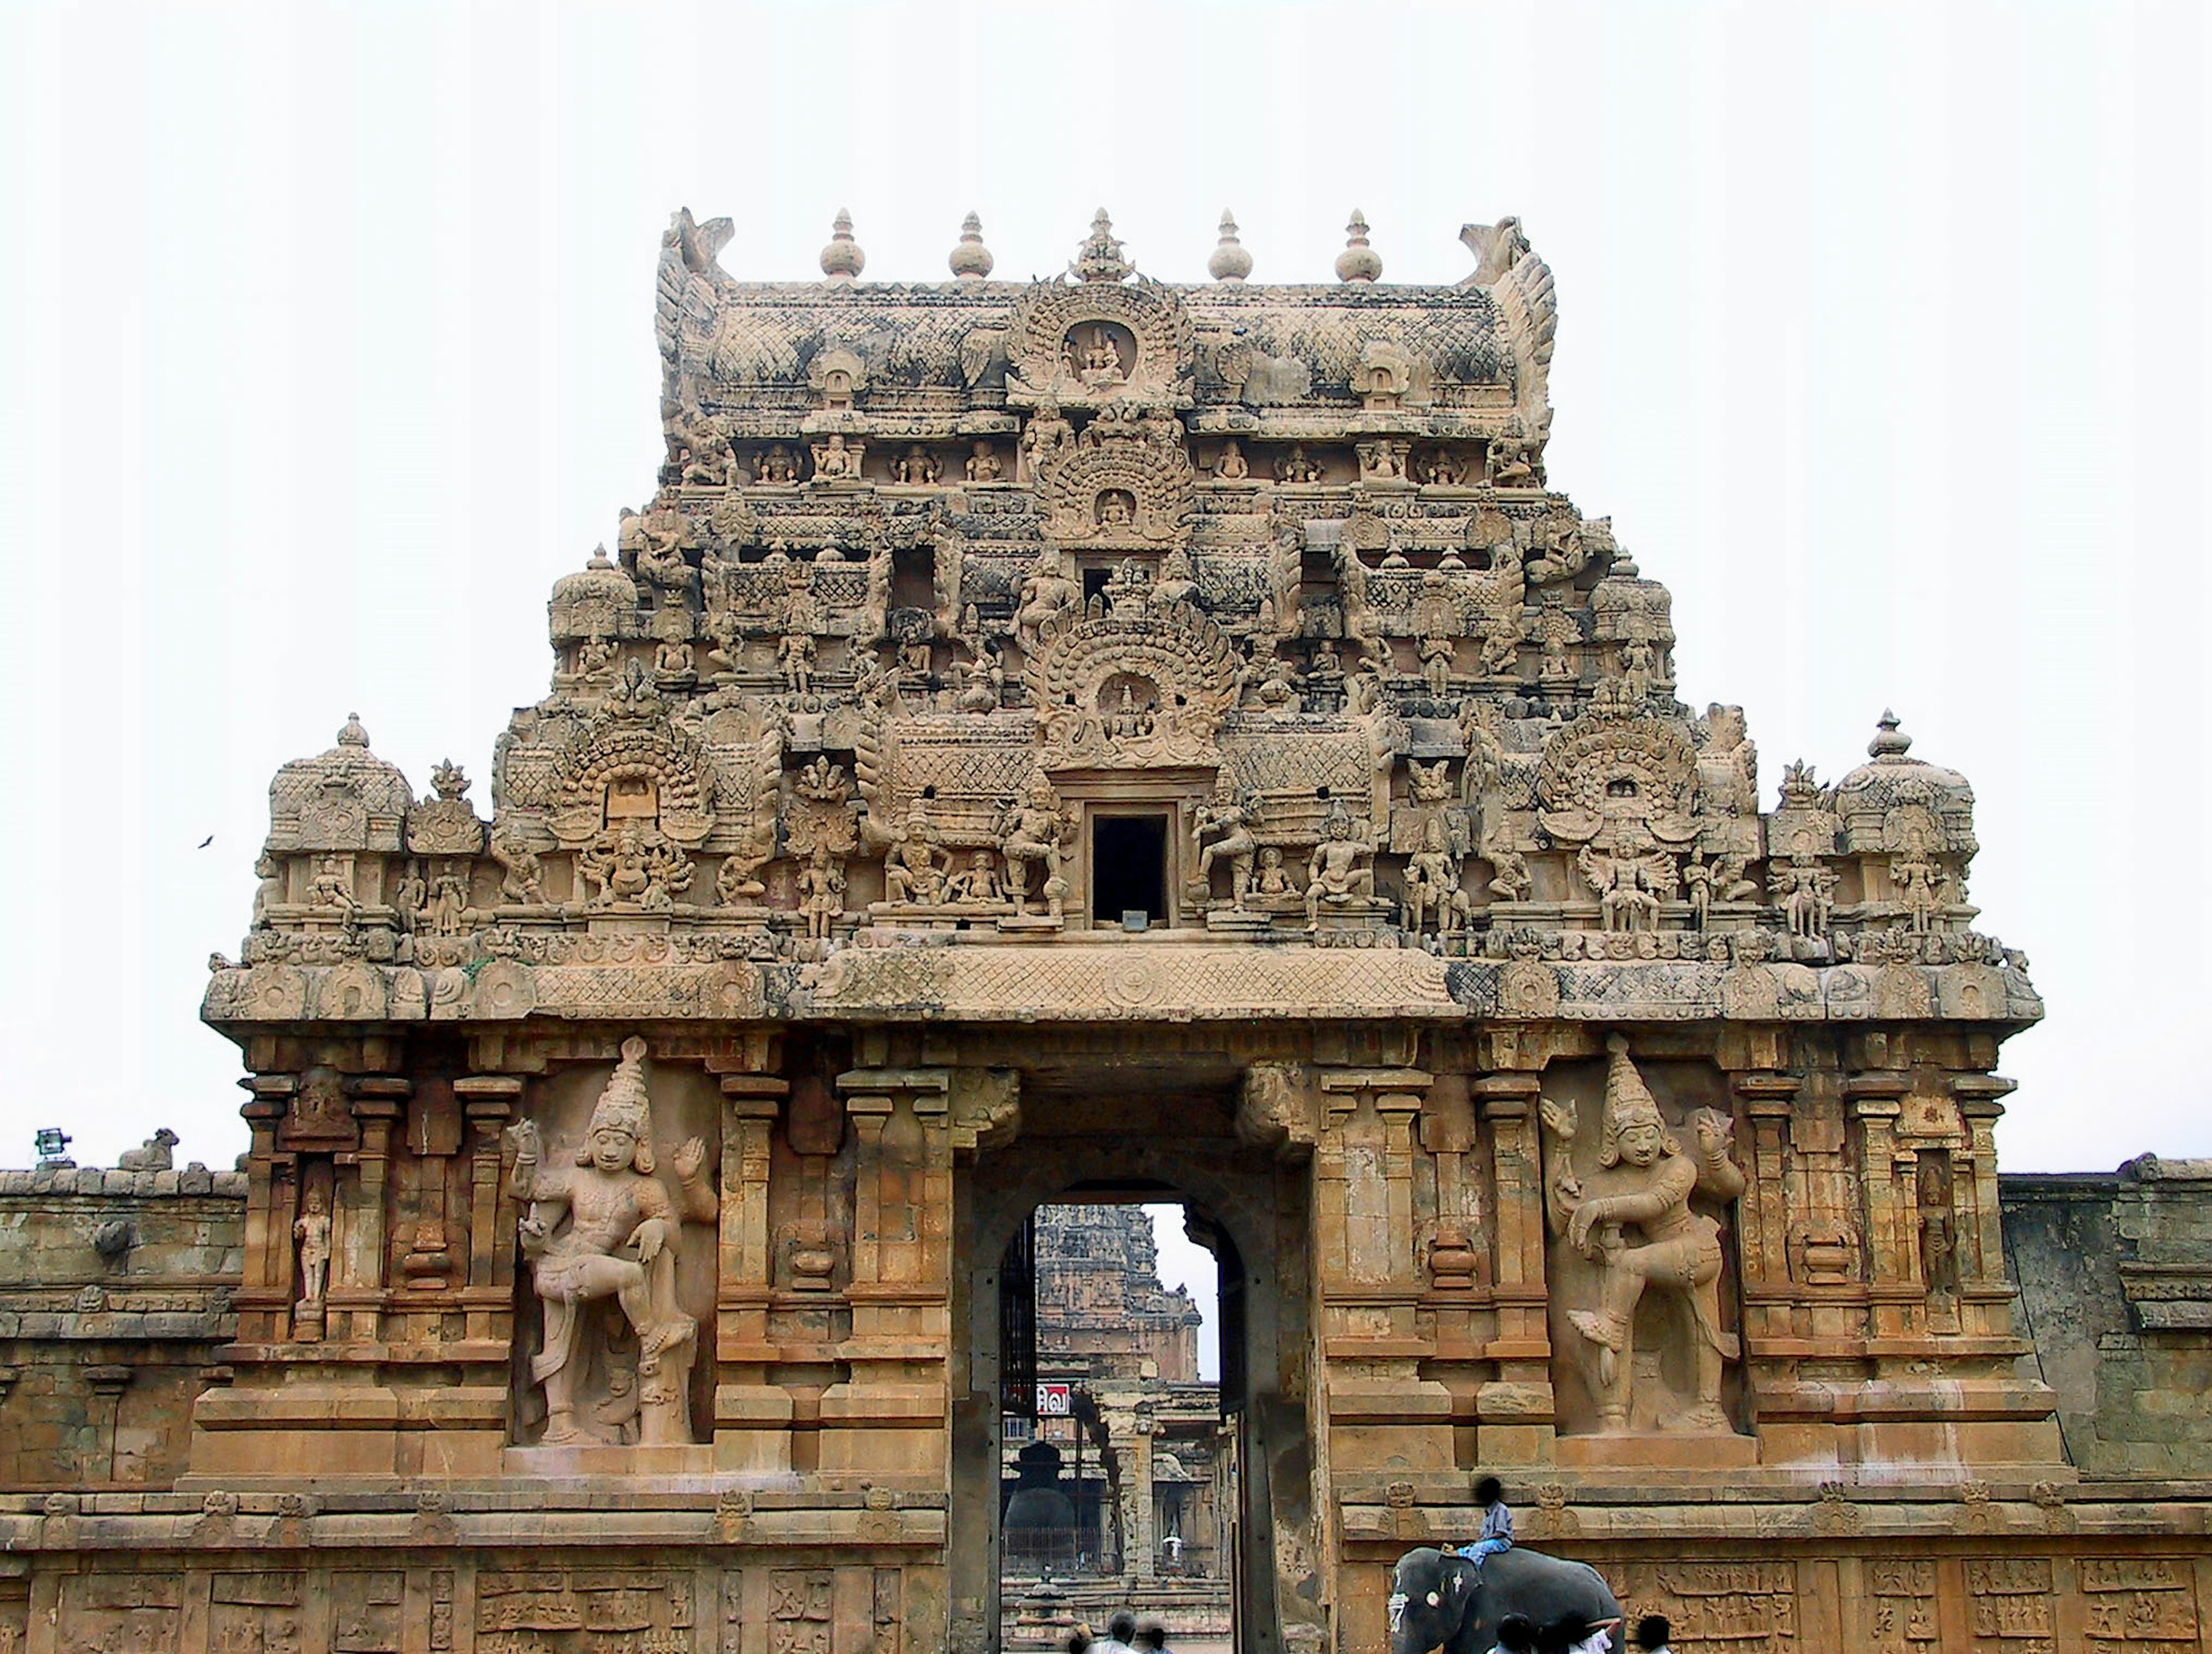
[0,213,2212,1654]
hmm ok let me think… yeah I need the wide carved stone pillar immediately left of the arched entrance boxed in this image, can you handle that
[821,1068,953,1488]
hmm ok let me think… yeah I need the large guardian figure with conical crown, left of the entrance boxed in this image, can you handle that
[509,1035,717,1446]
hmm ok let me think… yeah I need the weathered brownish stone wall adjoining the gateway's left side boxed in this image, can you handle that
[0,1165,245,1488]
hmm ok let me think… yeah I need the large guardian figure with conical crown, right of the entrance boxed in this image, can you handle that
[1540,1035,1745,1433]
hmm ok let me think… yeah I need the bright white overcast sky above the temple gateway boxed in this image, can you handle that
[0,0,2212,1170]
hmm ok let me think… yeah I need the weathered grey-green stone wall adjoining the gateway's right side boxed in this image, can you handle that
[1999,1154,2212,1480]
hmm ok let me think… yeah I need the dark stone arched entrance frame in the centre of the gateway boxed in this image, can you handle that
[951,1092,1314,1654]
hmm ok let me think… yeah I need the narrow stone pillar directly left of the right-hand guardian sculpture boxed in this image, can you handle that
[1473,1072,1557,1466]
